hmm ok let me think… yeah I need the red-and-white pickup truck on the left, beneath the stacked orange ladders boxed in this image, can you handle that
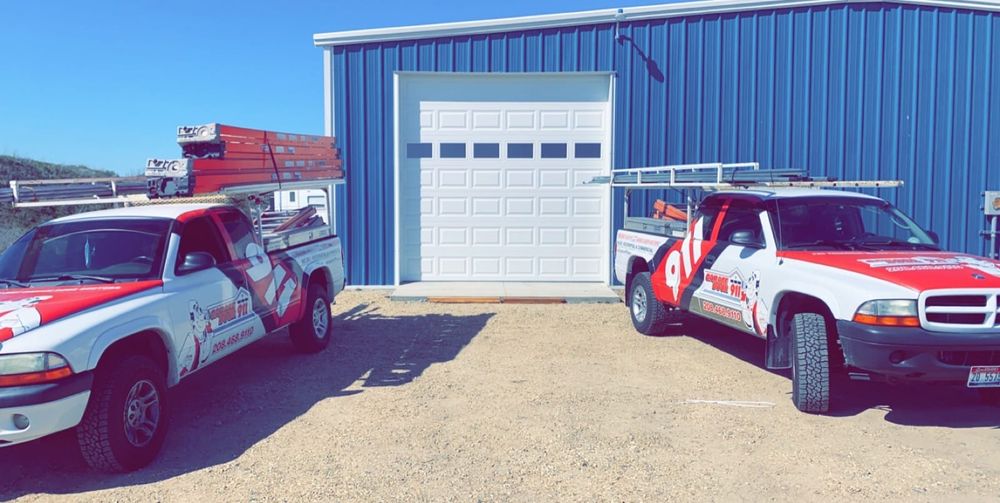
[0,204,344,471]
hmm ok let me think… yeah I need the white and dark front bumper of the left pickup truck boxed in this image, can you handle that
[0,372,94,447]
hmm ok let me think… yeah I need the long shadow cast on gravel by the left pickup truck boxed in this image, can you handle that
[0,304,493,501]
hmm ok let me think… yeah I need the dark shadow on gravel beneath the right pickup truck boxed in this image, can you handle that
[677,320,1000,429]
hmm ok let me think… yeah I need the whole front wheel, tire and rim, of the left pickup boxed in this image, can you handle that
[76,355,167,472]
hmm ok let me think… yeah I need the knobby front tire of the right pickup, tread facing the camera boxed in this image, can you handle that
[791,313,830,414]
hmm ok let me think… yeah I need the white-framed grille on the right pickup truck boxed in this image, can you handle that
[920,290,1000,331]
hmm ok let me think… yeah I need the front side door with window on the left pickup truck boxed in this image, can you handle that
[164,213,264,377]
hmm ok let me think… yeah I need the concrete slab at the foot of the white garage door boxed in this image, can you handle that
[389,281,621,304]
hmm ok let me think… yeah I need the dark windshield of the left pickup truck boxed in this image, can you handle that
[0,219,170,283]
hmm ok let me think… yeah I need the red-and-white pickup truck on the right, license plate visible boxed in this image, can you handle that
[615,188,1000,413]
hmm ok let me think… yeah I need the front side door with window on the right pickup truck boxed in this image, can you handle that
[690,196,776,337]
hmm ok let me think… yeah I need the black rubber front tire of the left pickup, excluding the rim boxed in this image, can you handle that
[76,355,169,472]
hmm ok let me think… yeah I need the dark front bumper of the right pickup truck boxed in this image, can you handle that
[837,321,1000,383]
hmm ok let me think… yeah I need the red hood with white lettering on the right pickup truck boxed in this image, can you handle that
[778,251,1000,292]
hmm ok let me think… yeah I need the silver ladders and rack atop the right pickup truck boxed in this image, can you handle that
[587,162,903,190]
